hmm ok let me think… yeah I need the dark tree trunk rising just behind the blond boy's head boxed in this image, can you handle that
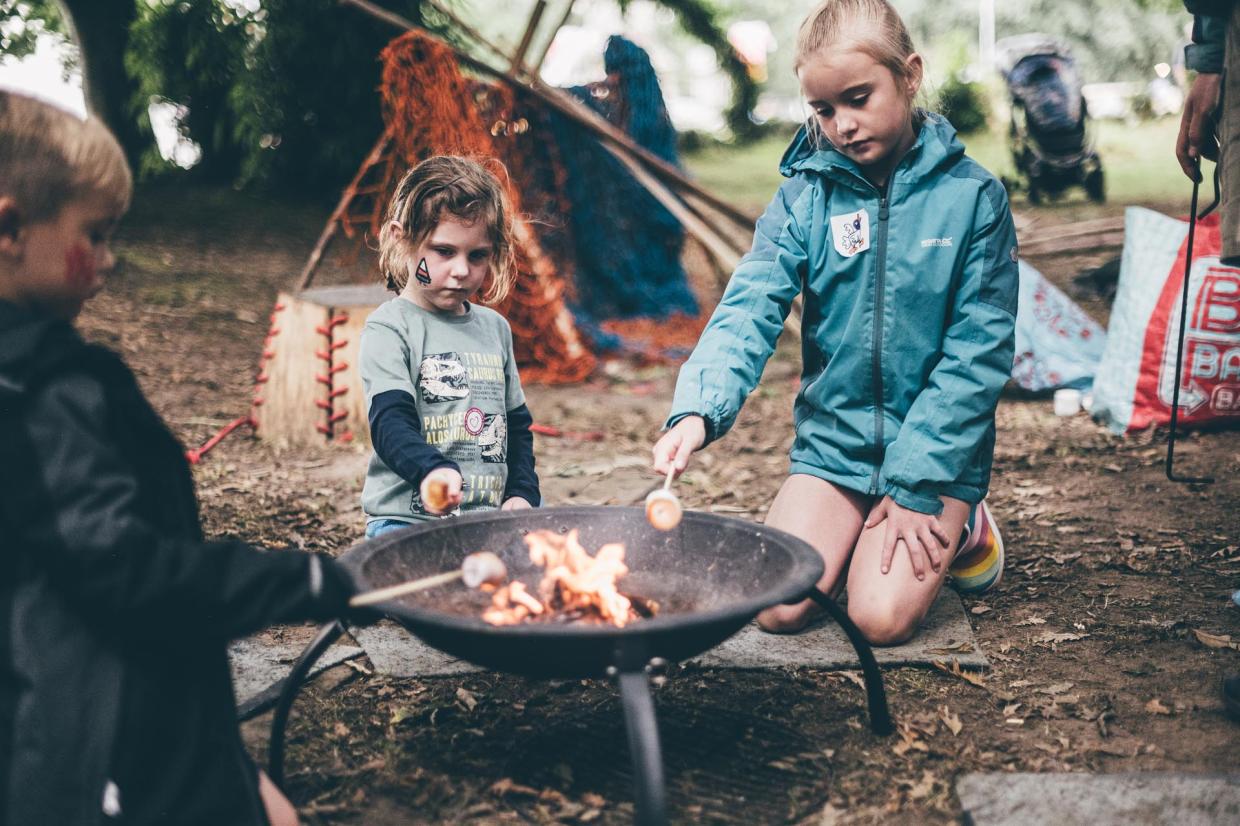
[58,0,151,165]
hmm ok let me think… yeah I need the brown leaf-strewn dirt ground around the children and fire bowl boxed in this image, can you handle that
[82,183,1240,826]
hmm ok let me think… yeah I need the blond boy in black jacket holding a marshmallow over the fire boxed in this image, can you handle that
[0,91,364,826]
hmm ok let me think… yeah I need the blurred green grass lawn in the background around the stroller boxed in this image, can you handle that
[684,118,1208,217]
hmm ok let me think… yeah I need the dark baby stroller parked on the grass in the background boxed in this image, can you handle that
[994,35,1106,205]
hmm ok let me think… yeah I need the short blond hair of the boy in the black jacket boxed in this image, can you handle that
[0,89,134,221]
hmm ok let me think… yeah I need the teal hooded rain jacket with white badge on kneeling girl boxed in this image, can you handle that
[667,114,1017,513]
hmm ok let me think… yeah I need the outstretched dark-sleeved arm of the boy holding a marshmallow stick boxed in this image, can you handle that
[0,375,353,639]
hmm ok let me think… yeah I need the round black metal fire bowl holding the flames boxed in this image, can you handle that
[345,507,823,677]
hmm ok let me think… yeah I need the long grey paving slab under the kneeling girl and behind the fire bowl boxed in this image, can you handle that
[353,589,990,677]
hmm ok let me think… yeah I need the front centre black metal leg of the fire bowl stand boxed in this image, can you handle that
[609,651,667,826]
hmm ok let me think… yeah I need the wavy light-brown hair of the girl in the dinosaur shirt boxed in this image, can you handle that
[379,155,517,304]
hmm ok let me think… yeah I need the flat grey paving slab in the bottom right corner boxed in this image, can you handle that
[956,771,1240,826]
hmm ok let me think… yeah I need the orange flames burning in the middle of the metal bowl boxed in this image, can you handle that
[482,530,658,628]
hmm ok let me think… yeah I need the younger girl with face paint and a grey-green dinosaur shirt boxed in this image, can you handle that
[360,156,541,537]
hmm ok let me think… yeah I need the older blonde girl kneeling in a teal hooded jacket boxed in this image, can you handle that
[653,0,1017,645]
